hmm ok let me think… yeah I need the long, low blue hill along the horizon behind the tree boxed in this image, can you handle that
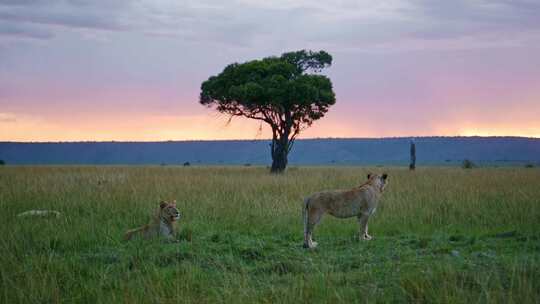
[0,137,540,165]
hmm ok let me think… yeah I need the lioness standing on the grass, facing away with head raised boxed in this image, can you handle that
[303,173,388,248]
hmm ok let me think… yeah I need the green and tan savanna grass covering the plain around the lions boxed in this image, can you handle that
[0,166,540,303]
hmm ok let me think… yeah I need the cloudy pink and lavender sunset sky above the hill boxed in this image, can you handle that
[0,0,540,141]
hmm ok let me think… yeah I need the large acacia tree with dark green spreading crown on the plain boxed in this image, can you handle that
[200,50,336,173]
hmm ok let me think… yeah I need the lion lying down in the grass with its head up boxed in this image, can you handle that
[124,201,180,242]
